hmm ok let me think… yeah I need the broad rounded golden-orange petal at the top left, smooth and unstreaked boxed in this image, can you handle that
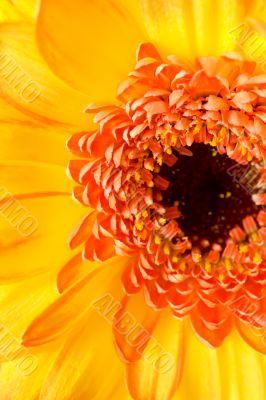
[37,0,145,102]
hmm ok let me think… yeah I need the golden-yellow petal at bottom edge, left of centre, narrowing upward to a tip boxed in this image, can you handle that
[40,312,129,400]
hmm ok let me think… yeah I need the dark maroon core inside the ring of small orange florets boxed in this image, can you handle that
[160,143,259,249]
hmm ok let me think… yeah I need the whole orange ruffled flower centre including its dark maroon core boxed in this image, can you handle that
[68,44,266,346]
